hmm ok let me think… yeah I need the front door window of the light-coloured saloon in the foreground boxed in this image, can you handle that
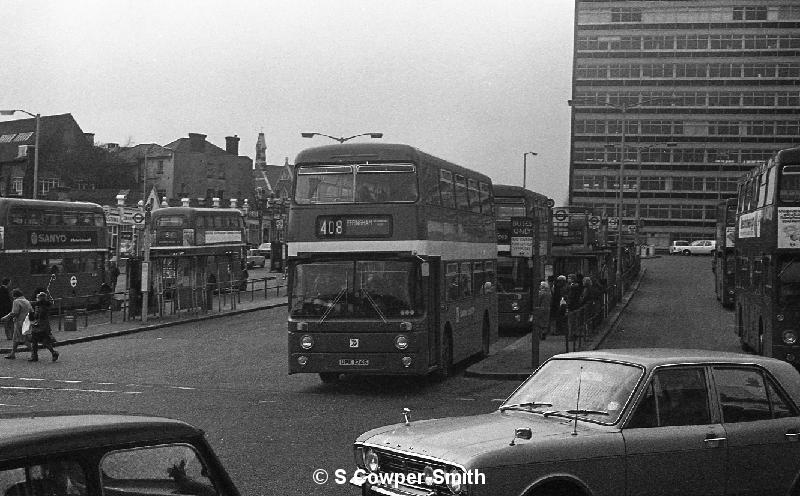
[628,367,711,428]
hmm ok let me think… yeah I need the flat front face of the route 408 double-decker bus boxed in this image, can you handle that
[287,145,433,382]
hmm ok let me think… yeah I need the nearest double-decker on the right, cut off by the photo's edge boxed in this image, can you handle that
[734,148,800,366]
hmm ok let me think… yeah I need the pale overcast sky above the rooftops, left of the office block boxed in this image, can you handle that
[0,0,574,205]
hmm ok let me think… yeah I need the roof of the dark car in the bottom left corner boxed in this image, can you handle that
[0,415,203,460]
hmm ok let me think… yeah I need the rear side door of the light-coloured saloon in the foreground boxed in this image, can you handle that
[713,366,800,496]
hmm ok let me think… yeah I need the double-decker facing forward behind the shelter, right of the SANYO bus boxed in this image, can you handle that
[149,207,246,308]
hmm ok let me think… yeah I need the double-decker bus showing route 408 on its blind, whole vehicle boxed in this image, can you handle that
[287,143,497,382]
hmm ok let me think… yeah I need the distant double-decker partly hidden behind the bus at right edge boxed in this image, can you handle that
[711,198,737,308]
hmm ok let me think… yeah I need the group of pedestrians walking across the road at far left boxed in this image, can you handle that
[0,279,59,362]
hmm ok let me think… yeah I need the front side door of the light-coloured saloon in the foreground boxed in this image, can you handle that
[622,366,727,496]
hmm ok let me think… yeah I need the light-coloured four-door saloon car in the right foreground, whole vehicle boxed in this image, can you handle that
[350,349,800,496]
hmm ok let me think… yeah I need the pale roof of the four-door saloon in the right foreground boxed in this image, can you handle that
[553,348,800,406]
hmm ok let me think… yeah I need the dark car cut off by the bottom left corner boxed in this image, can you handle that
[0,415,239,496]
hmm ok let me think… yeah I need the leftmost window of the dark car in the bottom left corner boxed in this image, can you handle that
[0,460,88,496]
